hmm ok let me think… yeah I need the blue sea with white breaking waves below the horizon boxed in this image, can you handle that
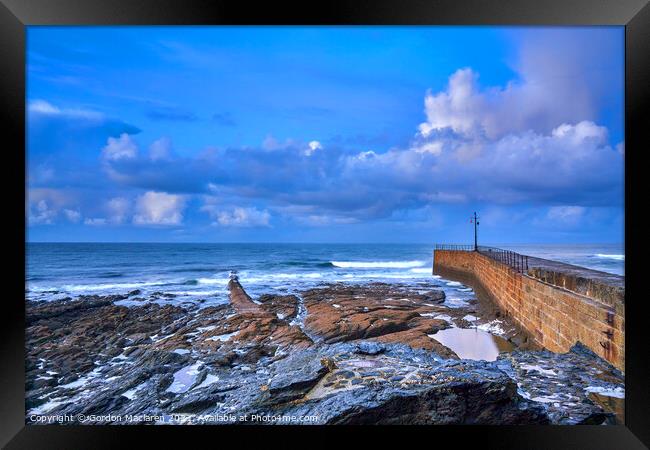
[25,243,625,306]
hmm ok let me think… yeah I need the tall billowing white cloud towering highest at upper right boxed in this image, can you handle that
[419,62,595,139]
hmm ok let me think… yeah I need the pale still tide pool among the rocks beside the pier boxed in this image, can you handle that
[429,328,514,361]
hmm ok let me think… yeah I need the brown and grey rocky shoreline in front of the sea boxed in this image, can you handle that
[26,279,624,424]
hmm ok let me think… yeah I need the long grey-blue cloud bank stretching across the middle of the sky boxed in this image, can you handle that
[100,112,623,224]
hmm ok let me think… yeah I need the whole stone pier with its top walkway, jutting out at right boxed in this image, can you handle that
[433,250,625,371]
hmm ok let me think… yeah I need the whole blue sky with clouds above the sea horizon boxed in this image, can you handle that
[25,26,625,243]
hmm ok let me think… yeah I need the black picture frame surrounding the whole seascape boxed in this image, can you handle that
[0,0,650,449]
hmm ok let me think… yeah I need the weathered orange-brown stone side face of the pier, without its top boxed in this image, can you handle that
[433,250,625,371]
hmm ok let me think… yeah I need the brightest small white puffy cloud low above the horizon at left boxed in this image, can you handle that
[133,191,185,225]
